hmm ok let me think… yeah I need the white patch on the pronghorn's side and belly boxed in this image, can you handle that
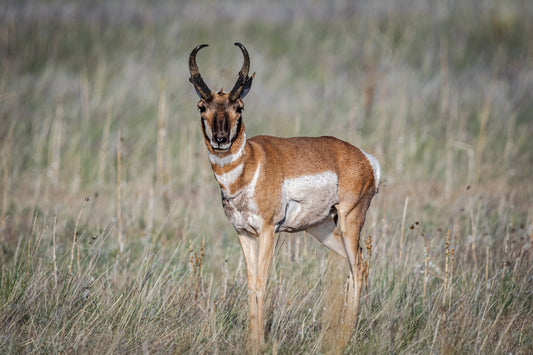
[276,171,339,232]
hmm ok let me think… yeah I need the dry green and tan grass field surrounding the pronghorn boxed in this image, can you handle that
[0,0,533,354]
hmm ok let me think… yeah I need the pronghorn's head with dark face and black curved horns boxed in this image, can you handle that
[189,43,255,154]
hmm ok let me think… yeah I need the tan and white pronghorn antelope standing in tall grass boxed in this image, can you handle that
[189,43,381,345]
